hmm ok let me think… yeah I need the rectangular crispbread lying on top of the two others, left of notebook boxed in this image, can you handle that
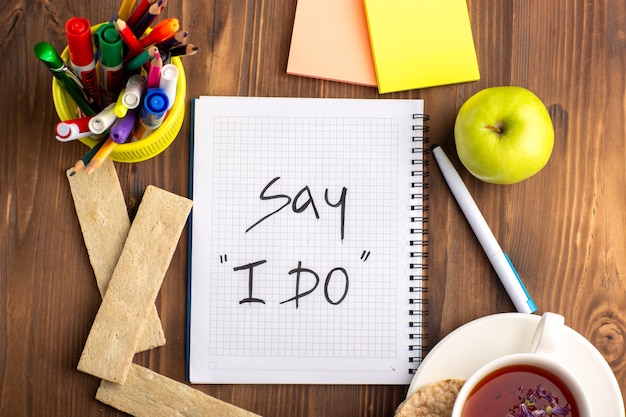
[78,186,191,384]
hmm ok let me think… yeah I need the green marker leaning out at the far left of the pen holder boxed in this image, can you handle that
[34,42,98,116]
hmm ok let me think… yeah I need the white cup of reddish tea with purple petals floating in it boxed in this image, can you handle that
[452,312,592,417]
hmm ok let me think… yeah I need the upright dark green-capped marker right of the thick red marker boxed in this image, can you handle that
[97,23,124,106]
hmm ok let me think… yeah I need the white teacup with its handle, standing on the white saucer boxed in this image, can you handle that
[452,313,592,417]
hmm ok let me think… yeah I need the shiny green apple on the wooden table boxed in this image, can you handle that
[454,86,554,184]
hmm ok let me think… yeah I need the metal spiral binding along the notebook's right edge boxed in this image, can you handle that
[409,114,429,374]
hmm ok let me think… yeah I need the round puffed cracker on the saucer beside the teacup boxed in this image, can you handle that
[395,379,465,417]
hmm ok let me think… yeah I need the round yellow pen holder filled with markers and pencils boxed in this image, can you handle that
[52,25,187,162]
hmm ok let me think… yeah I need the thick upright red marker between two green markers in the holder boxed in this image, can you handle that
[65,17,100,104]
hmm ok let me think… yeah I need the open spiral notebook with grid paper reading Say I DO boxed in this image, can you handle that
[188,97,427,384]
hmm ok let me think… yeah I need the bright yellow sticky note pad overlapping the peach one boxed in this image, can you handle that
[364,0,480,94]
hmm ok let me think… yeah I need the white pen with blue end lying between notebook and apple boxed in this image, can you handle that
[432,145,537,313]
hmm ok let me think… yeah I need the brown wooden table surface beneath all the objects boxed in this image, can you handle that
[0,0,626,417]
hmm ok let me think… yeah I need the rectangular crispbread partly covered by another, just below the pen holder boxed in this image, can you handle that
[66,160,165,352]
